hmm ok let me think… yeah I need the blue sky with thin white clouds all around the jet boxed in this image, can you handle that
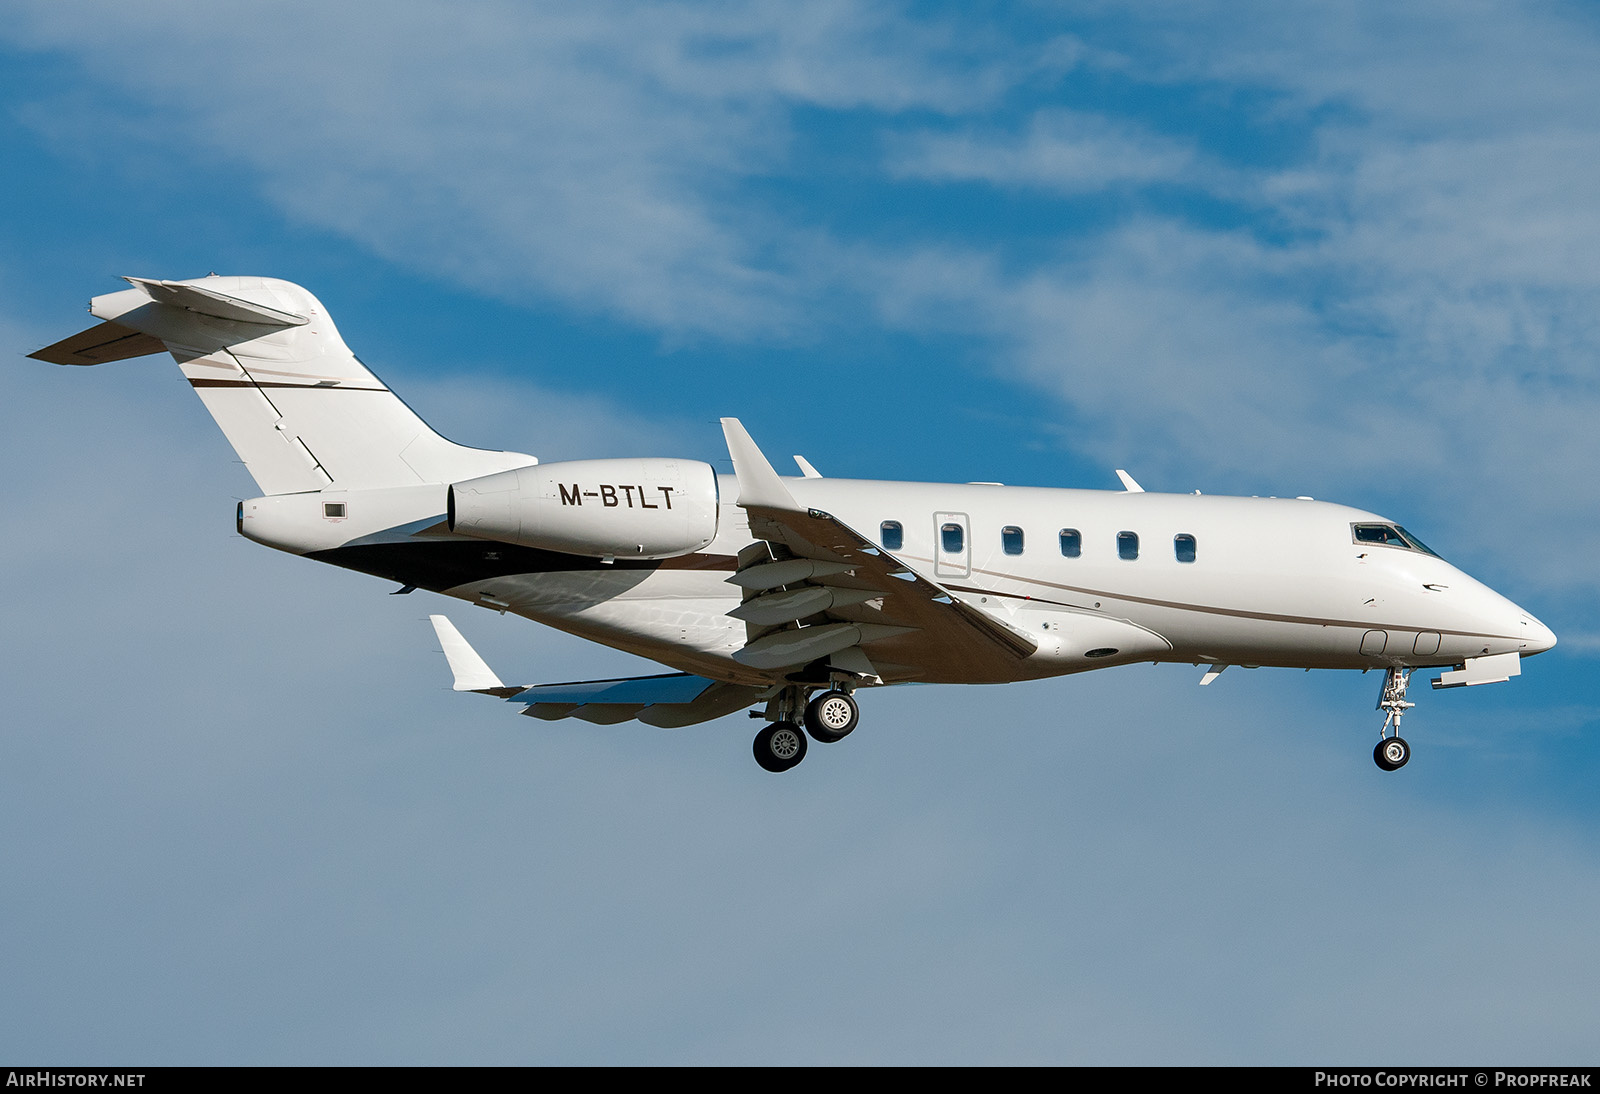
[0,0,1600,1064]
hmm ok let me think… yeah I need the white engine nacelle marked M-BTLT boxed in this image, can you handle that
[448,459,717,558]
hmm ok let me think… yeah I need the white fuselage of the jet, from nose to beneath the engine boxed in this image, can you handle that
[435,477,1555,683]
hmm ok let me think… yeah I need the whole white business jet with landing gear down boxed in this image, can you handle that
[32,277,1555,771]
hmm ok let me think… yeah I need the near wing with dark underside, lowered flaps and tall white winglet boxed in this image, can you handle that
[722,417,1037,683]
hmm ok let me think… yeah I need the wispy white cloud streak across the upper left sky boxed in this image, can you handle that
[11,0,1005,336]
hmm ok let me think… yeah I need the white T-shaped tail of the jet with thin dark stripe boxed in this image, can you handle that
[30,277,538,494]
